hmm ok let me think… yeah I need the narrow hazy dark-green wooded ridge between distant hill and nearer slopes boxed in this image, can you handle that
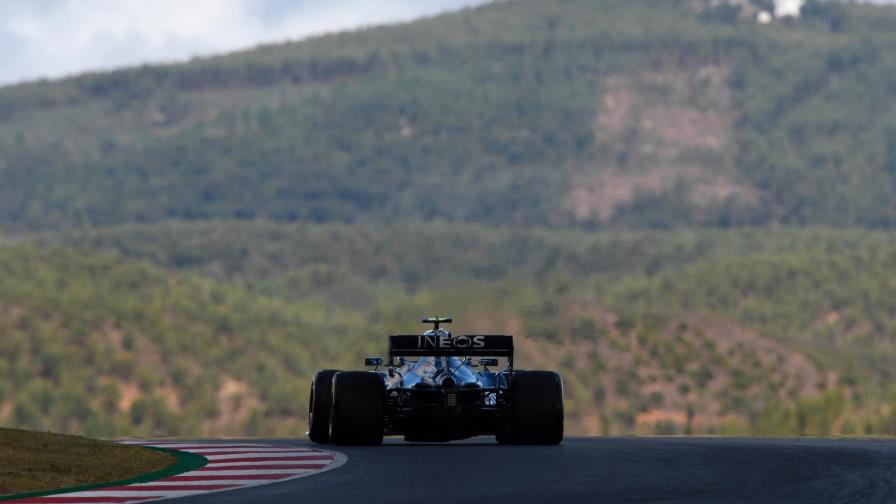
[47,221,896,304]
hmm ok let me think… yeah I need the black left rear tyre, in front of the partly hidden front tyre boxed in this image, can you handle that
[330,371,385,445]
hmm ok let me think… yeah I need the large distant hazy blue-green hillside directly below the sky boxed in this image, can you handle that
[0,0,896,230]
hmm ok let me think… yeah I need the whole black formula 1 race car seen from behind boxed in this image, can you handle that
[308,317,563,445]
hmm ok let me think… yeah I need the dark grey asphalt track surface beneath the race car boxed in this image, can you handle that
[167,438,896,504]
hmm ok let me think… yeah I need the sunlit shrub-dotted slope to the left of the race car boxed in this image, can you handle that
[0,247,376,436]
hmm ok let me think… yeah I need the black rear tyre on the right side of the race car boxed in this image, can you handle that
[496,371,563,445]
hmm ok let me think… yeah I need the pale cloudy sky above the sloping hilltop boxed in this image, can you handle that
[0,0,896,85]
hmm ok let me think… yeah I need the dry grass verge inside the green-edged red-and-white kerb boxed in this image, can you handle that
[0,429,189,499]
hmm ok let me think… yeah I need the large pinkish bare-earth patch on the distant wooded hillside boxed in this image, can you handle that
[565,65,757,221]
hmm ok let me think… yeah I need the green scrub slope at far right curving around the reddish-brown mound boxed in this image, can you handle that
[605,246,896,434]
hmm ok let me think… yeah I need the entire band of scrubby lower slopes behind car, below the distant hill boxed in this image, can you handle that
[0,222,896,434]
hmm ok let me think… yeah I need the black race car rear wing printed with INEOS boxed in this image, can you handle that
[389,334,513,362]
